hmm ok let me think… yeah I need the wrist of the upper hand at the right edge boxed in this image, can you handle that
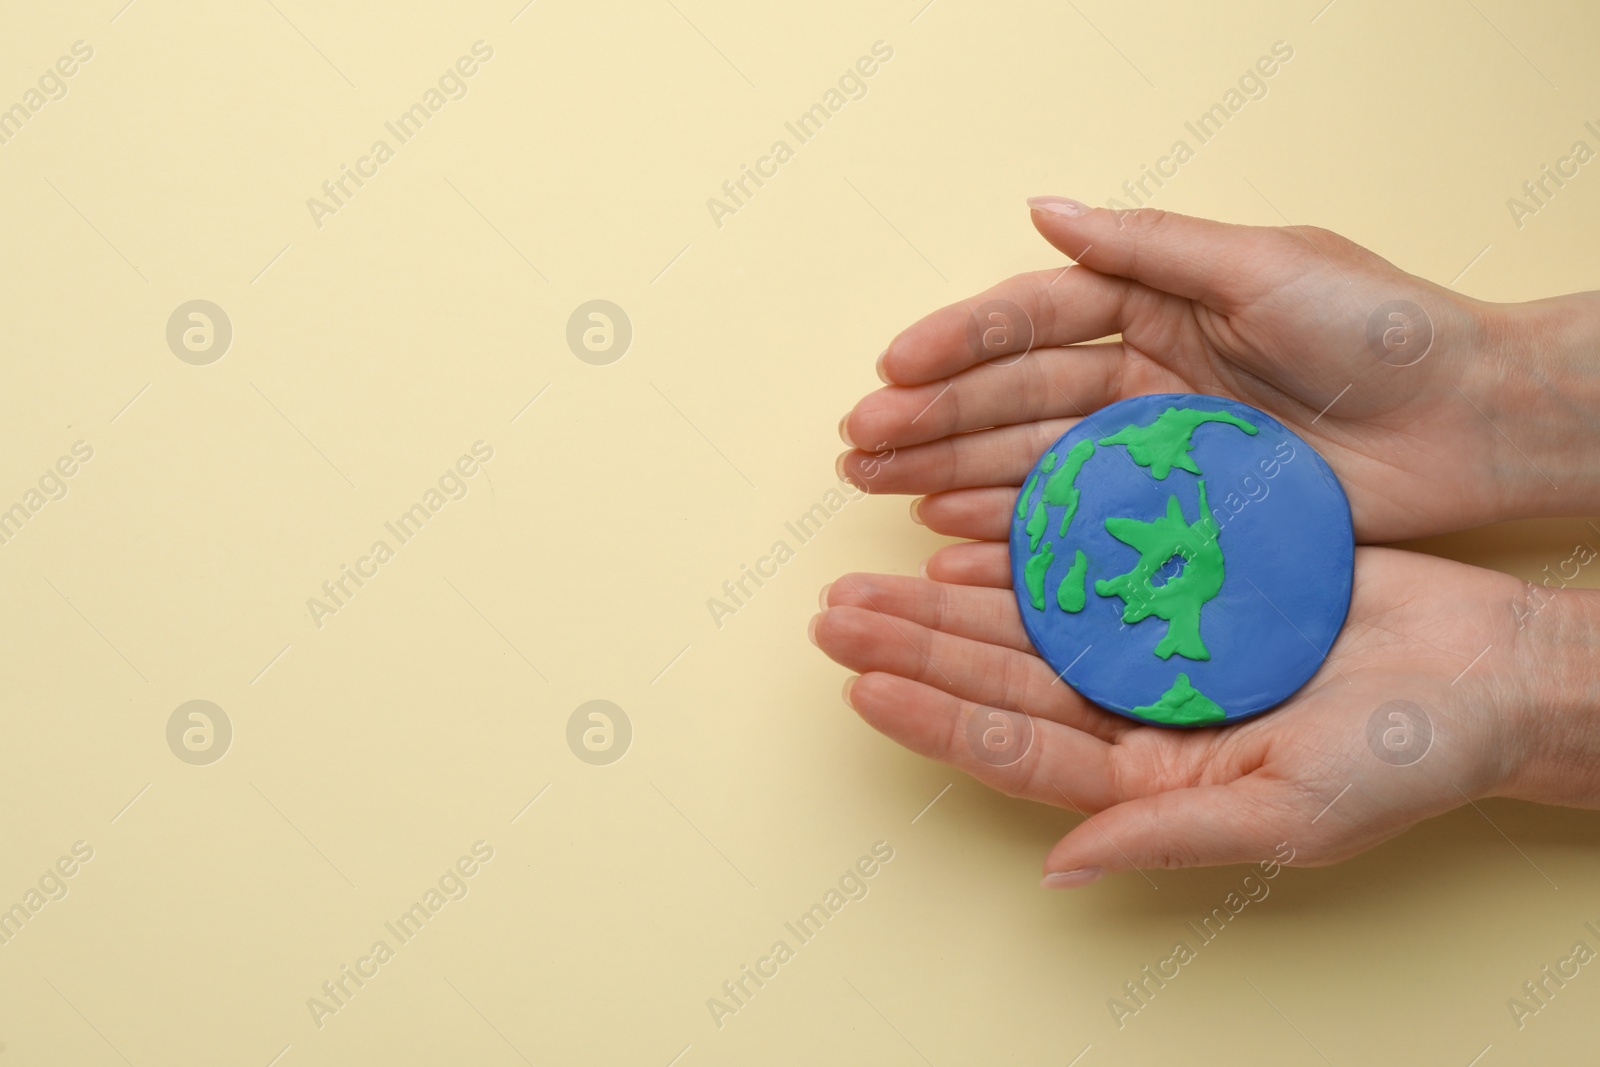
[1461,293,1600,518]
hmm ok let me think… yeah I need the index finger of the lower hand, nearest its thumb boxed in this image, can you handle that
[845,673,1117,811]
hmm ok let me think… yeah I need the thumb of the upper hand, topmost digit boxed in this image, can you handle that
[1027,197,1318,312]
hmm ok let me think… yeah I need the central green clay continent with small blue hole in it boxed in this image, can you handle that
[1100,482,1222,661]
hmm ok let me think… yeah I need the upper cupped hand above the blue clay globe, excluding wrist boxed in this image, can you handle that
[840,197,1544,542]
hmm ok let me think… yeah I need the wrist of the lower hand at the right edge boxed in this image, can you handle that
[1494,579,1600,808]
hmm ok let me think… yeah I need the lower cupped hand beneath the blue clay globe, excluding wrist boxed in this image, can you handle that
[811,544,1541,888]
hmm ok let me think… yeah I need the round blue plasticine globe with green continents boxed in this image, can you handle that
[1011,394,1355,726]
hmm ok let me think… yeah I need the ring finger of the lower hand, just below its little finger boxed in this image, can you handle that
[822,574,1034,654]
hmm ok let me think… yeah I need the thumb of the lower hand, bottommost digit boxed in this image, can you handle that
[1043,774,1306,888]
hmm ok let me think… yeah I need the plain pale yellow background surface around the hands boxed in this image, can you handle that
[0,0,1600,1067]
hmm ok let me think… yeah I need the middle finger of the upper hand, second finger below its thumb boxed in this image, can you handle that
[840,342,1139,451]
